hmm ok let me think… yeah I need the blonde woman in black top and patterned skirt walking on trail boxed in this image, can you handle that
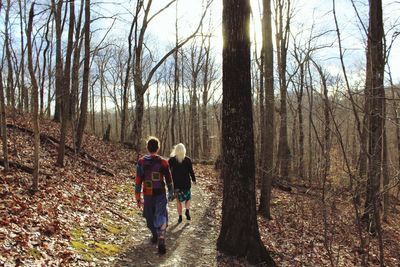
[168,143,196,223]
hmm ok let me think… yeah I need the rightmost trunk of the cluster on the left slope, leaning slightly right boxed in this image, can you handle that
[76,0,90,152]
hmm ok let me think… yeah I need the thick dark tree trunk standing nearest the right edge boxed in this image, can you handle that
[365,0,385,243]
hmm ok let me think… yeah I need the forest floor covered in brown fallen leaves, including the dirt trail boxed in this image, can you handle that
[0,112,400,266]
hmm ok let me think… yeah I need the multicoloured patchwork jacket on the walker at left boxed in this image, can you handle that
[135,155,173,201]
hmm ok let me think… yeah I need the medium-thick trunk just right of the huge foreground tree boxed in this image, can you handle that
[259,0,275,218]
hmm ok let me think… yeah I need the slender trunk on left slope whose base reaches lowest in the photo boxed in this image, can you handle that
[27,2,40,191]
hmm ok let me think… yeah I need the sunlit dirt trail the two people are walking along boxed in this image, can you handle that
[115,184,217,266]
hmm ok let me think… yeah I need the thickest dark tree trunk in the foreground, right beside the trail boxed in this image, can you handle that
[217,0,275,266]
